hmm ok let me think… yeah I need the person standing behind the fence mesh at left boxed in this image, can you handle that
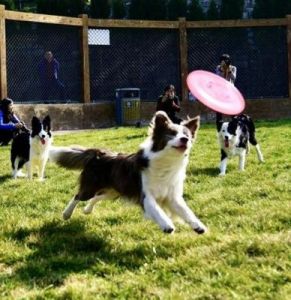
[39,51,65,100]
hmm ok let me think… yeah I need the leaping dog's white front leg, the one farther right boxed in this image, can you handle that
[169,197,207,234]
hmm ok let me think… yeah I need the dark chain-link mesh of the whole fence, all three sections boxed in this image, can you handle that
[6,21,289,103]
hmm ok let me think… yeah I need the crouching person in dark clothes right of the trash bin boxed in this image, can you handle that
[156,84,182,124]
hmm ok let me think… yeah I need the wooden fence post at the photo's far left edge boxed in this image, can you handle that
[0,5,7,99]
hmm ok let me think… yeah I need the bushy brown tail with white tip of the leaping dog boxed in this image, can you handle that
[49,147,98,170]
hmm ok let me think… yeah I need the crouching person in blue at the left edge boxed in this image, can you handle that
[0,98,25,146]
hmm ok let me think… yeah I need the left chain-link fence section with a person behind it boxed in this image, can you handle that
[6,21,82,103]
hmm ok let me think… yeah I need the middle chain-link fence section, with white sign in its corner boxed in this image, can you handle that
[89,28,181,101]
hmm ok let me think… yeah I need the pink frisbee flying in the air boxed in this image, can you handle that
[187,70,245,115]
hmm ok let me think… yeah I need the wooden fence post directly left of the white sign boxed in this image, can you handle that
[79,14,91,103]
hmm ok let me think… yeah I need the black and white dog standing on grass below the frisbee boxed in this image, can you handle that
[216,113,264,175]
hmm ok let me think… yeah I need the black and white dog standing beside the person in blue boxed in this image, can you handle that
[11,116,52,181]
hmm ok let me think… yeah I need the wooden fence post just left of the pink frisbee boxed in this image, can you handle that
[179,18,188,103]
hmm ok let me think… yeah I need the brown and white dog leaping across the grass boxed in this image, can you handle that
[50,111,206,234]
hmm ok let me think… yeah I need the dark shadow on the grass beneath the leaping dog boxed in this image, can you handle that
[8,220,164,288]
